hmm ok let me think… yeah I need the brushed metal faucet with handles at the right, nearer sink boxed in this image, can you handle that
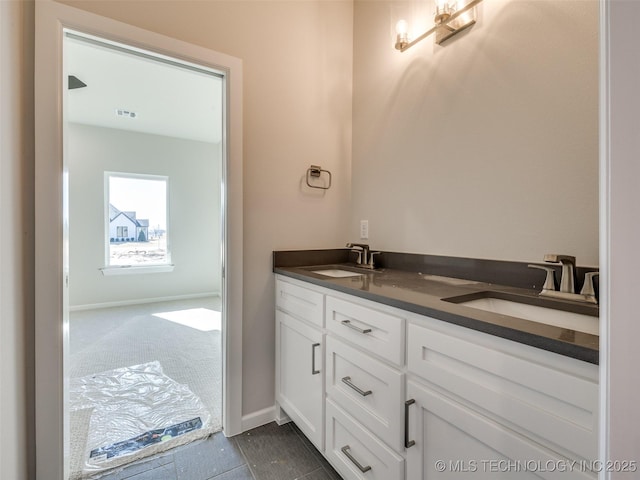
[528,253,599,303]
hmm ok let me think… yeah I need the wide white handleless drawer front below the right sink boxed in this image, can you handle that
[407,324,598,459]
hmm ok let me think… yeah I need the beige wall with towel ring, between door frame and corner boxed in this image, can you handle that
[57,0,353,415]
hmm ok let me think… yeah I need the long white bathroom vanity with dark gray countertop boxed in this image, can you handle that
[274,251,598,480]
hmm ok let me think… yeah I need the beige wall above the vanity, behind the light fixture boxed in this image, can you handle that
[349,0,598,265]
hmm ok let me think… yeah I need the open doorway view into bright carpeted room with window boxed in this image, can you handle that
[63,30,224,479]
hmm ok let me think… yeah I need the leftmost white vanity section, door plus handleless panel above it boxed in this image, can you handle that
[276,280,324,451]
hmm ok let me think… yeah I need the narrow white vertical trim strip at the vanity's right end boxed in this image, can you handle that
[598,0,611,480]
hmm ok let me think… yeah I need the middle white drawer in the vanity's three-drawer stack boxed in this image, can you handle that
[326,337,404,451]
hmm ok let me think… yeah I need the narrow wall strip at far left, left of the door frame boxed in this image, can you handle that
[0,1,35,480]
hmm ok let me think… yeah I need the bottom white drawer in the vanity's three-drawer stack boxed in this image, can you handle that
[325,399,404,480]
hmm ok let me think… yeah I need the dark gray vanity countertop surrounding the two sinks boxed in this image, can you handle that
[274,263,599,364]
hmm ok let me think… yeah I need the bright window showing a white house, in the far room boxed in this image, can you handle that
[105,172,171,267]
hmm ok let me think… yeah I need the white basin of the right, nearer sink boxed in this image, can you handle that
[458,297,600,335]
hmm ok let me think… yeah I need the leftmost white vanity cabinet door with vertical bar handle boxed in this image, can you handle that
[276,310,324,451]
